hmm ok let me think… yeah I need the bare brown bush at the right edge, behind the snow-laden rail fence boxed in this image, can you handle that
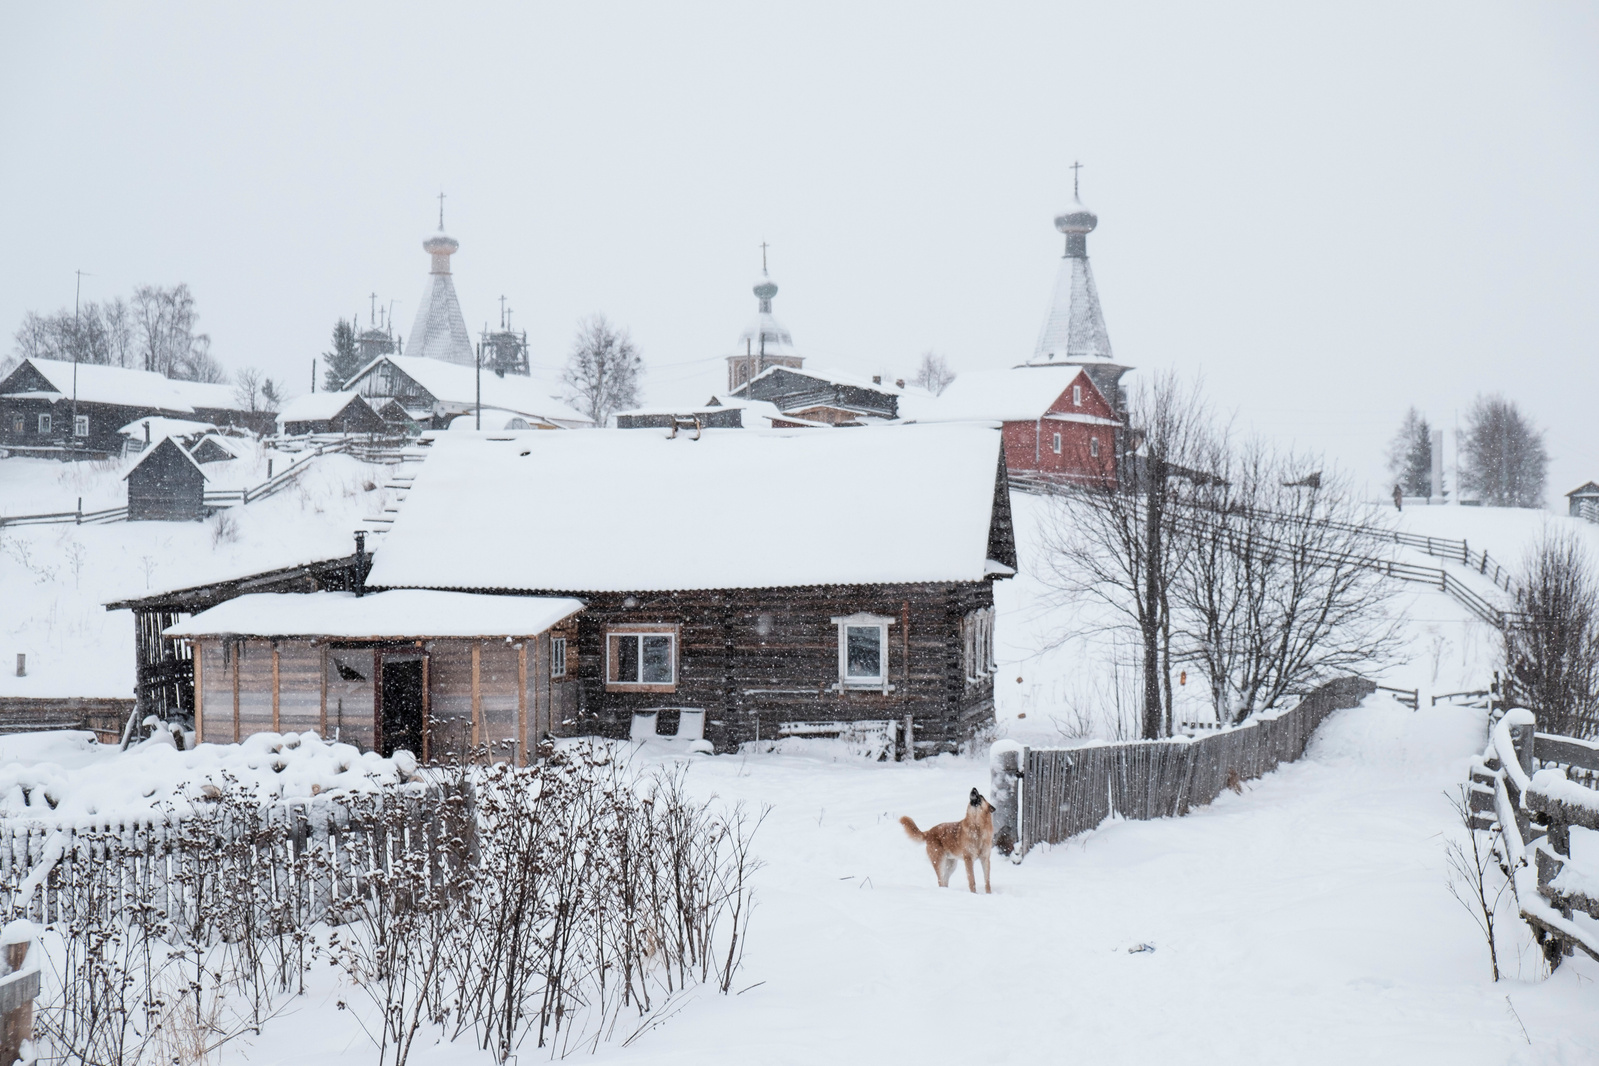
[1503,532,1599,737]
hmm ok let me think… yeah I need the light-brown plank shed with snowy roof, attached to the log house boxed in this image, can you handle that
[165,590,584,762]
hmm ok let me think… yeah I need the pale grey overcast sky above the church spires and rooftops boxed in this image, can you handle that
[0,2,1599,505]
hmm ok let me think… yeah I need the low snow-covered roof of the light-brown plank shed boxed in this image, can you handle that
[165,588,584,639]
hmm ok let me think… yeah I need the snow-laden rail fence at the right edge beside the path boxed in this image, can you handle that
[1469,708,1599,970]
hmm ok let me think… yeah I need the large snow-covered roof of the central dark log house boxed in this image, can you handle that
[369,424,999,591]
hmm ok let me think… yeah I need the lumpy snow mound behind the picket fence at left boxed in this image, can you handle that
[0,732,416,828]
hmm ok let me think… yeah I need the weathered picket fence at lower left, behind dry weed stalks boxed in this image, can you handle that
[0,783,477,935]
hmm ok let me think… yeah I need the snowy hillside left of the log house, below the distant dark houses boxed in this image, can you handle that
[0,446,395,697]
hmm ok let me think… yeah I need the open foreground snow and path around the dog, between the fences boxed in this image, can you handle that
[546,698,1599,1066]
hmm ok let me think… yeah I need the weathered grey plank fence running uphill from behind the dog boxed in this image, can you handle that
[991,678,1377,860]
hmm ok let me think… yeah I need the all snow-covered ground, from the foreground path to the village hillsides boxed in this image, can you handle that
[0,455,1599,1066]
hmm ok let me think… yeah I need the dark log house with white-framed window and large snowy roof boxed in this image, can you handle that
[371,424,1017,753]
